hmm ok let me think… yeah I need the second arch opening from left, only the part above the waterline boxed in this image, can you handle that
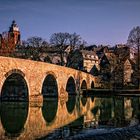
[42,74,58,97]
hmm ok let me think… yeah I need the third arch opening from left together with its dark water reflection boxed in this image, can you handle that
[66,77,76,113]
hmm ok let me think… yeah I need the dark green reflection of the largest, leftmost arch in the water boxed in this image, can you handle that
[0,102,28,138]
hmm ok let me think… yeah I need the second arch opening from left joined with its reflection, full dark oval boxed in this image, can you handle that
[42,73,58,123]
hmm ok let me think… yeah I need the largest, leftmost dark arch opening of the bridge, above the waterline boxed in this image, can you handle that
[1,72,29,101]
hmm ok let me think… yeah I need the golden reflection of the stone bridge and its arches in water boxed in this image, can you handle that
[0,94,94,139]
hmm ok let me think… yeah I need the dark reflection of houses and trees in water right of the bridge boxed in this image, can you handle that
[92,96,140,127]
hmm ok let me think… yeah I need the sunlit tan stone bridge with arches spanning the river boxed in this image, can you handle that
[0,56,98,101]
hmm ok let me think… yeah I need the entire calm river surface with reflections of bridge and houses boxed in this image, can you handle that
[0,95,140,140]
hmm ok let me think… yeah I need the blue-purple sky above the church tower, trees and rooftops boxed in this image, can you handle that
[0,0,140,45]
